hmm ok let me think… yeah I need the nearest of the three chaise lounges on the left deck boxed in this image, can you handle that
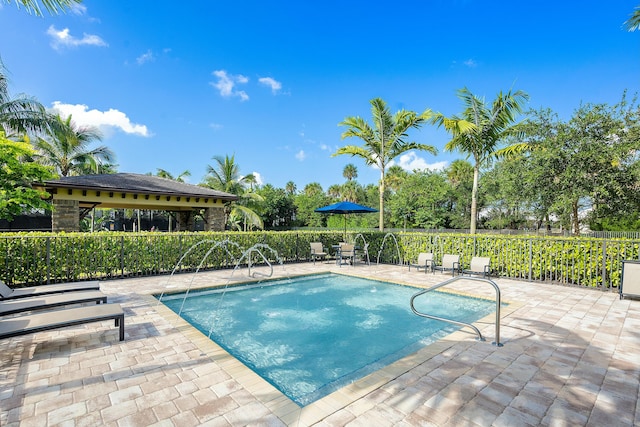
[0,304,124,341]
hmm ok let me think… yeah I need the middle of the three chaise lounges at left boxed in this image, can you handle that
[0,291,107,316]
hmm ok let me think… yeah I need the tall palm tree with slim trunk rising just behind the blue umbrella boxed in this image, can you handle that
[332,98,437,231]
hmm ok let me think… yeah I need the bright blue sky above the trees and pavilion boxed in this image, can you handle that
[0,0,640,190]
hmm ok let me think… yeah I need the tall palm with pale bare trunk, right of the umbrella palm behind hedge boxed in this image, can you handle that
[433,87,529,234]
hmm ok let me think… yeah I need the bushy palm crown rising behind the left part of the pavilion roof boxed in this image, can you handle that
[34,114,114,176]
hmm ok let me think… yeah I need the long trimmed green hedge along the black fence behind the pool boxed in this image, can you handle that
[0,231,640,289]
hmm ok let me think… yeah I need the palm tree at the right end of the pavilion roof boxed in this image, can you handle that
[203,155,264,229]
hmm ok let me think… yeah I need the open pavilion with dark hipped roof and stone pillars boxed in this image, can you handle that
[33,173,237,232]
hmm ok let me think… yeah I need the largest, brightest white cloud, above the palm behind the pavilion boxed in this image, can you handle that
[51,101,151,137]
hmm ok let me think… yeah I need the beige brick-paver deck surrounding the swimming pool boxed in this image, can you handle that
[0,263,640,427]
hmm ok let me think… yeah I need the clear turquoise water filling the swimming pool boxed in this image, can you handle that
[162,274,495,406]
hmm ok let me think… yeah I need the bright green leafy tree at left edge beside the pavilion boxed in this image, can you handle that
[0,131,53,221]
